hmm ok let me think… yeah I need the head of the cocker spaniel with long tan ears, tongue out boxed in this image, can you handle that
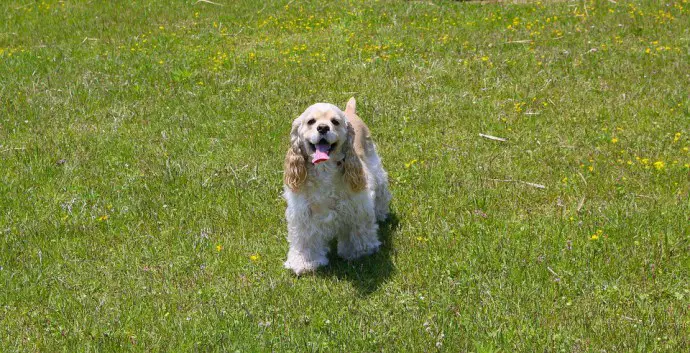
[285,103,365,191]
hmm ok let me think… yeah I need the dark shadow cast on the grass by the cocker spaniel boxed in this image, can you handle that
[317,212,399,296]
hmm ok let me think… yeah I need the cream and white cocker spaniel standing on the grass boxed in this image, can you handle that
[284,98,391,275]
